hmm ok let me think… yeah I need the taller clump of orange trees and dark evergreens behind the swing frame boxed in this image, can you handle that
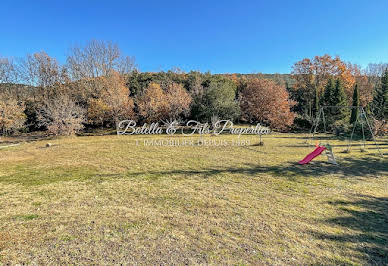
[289,55,388,134]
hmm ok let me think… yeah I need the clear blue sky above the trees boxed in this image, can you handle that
[0,0,388,73]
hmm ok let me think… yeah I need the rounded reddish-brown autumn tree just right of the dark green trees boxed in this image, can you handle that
[241,78,295,130]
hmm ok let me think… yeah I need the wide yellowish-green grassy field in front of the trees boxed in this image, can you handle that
[0,134,388,265]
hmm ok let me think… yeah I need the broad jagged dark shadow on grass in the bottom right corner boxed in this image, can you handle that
[312,196,388,265]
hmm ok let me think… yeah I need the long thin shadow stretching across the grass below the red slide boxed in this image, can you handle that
[128,157,388,180]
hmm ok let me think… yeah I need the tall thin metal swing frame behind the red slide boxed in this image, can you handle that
[306,106,384,158]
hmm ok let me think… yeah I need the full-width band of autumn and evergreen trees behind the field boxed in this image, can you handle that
[0,40,388,135]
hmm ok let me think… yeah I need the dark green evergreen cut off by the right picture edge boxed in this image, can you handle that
[372,69,388,120]
